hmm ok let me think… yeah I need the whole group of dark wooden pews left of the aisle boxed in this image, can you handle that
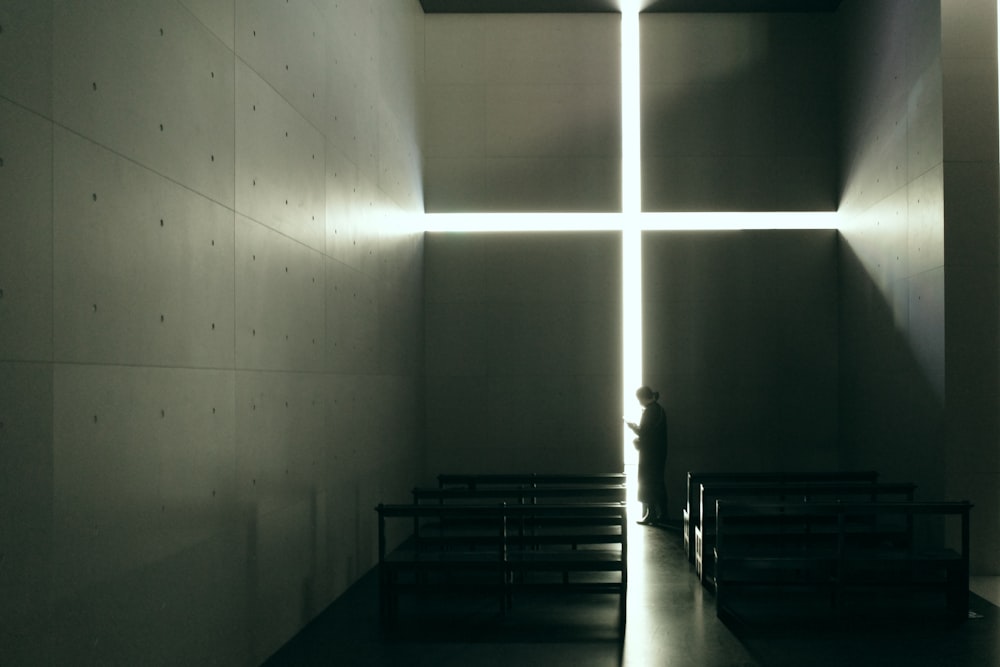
[376,476,628,632]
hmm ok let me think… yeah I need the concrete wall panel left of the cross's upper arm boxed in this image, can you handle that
[425,14,621,212]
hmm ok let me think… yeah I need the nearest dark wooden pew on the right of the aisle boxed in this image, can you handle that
[715,500,972,621]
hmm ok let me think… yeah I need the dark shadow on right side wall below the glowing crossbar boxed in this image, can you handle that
[839,237,944,500]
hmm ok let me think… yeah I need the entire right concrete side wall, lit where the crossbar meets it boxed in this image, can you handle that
[839,0,1000,574]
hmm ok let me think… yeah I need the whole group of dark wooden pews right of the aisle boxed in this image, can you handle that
[684,471,972,619]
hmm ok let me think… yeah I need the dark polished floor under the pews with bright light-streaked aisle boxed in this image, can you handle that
[266,526,1000,667]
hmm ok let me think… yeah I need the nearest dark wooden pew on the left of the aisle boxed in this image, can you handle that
[376,502,628,632]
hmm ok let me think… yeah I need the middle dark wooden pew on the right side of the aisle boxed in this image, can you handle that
[695,481,917,586]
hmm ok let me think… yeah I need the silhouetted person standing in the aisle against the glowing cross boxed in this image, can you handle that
[626,386,667,525]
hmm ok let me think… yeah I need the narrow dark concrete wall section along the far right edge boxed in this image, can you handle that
[941,0,1000,575]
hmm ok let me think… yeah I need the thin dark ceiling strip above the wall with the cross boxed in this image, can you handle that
[420,0,841,14]
